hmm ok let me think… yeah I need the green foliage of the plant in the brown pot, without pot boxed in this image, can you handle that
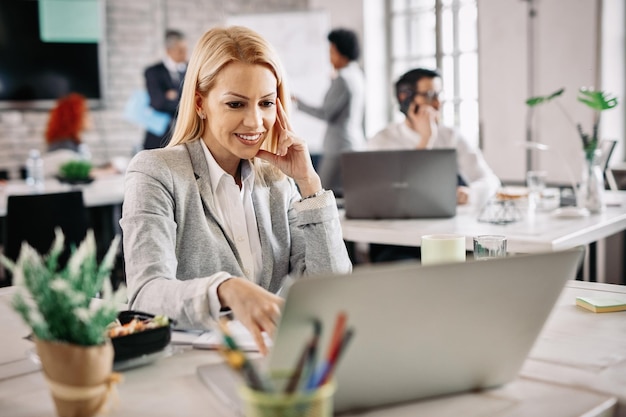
[0,228,126,346]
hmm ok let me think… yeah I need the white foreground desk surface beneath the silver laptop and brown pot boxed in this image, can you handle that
[0,282,626,417]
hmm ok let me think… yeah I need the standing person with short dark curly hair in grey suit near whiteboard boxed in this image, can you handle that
[292,29,365,197]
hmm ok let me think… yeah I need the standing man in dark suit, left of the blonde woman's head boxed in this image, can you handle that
[143,29,187,149]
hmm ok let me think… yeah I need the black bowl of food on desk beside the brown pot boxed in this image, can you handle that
[111,310,172,362]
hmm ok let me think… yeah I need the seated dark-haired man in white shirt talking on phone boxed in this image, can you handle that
[367,68,500,204]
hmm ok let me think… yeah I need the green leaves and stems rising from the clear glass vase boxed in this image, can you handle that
[526,87,618,160]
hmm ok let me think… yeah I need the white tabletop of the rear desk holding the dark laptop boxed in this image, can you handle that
[341,191,626,253]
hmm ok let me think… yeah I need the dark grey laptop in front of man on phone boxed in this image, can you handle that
[341,149,457,219]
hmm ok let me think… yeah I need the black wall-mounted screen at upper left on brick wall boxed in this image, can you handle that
[0,0,103,109]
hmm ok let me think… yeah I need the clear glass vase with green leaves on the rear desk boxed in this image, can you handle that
[526,87,618,213]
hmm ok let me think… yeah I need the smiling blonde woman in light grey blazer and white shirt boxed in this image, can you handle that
[120,27,352,353]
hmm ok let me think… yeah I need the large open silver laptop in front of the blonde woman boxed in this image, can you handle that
[198,250,582,412]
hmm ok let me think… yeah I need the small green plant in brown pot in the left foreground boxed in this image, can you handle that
[0,228,126,417]
